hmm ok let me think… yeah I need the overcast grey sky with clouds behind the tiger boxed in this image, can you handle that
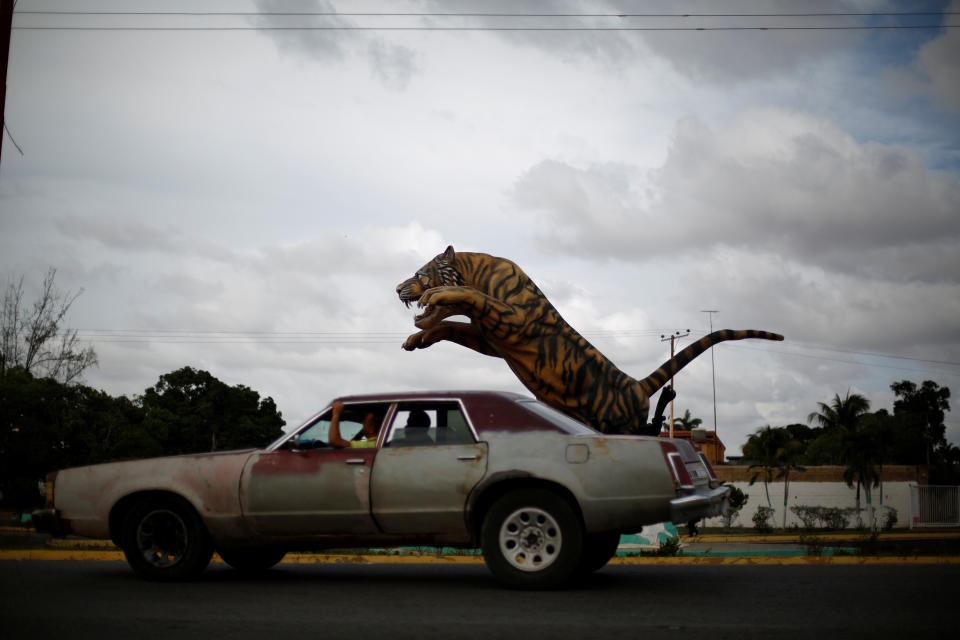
[0,0,960,454]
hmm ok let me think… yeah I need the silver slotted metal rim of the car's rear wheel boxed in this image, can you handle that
[500,507,563,571]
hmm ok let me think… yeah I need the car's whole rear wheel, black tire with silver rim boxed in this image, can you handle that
[481,489,583,589]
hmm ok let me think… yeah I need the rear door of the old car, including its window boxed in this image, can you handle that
[370,400,487,534]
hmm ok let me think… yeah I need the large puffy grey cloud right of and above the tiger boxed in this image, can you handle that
[515,109,960,282]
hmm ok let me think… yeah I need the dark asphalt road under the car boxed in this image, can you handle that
[0,561,960,640]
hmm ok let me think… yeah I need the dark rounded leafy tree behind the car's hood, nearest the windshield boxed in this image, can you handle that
[139,367,284,455]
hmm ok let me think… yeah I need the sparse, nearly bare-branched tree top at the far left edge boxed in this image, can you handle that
[0,268,97,382]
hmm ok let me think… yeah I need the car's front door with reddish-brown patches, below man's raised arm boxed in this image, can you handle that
[240,406,386,538]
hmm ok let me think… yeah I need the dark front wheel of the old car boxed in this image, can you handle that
[122,497,213,582]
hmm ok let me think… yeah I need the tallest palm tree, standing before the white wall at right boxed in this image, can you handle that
[807,389,880,529]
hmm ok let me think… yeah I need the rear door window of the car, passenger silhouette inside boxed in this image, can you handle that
[387,401,473,447]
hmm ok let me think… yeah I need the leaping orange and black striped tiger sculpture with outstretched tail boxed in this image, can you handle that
[397,246,783,435]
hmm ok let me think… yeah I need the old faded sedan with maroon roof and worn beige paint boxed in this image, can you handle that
[34,391,728,587]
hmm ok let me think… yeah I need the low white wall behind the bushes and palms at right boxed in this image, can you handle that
[704,480,911,529]
